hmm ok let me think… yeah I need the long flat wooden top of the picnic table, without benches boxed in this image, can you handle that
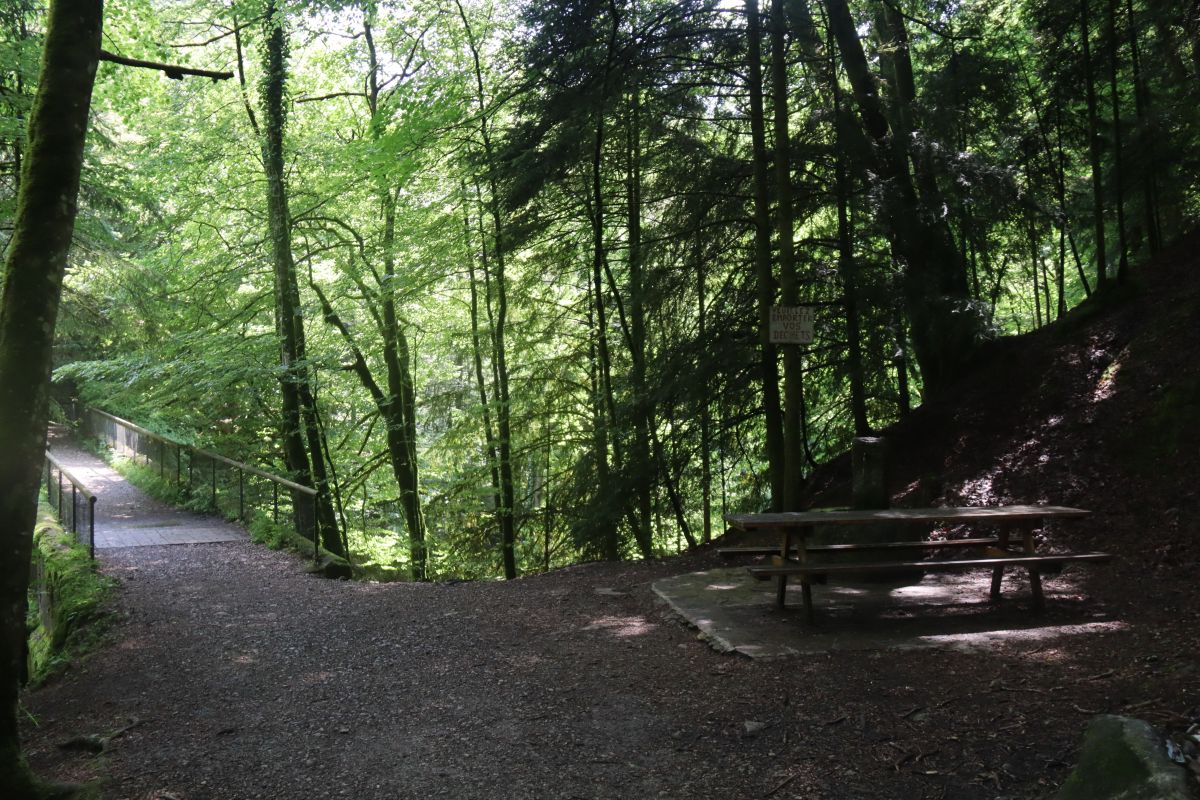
[725,505,1091,530]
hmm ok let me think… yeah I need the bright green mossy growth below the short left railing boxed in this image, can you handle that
[28,507,114,685]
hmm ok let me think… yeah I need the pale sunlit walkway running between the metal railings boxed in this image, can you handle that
[50,437,248,549]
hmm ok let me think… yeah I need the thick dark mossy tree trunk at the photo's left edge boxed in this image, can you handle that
[0,0,103,799]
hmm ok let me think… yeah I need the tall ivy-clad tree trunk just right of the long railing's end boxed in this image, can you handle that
[263,0,346,557]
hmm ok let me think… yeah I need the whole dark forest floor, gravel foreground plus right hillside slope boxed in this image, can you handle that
[18,239,1200,800]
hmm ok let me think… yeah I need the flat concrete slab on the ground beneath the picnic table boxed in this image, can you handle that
[654,567,1124,658]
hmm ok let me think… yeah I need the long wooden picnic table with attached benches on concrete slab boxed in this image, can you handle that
[720,505,1111,621]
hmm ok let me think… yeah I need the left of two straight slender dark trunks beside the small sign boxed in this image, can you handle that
[745,0,787,511]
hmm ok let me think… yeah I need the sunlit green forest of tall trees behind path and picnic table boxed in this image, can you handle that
[0,0,1200,581]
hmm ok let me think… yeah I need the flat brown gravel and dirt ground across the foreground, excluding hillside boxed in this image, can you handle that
[18,543,1196,800]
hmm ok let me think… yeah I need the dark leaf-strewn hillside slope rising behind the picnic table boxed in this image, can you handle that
[809,235,1200,599]
